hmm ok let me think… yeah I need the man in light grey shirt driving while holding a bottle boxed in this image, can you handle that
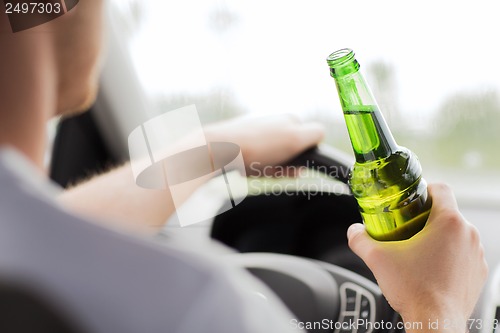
[0,0,486,333]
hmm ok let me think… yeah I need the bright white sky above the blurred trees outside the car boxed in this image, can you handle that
[113,0,500,122]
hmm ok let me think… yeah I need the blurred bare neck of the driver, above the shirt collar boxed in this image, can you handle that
[0,32,56,168]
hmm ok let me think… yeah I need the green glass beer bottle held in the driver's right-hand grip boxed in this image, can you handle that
[327,49,431,241]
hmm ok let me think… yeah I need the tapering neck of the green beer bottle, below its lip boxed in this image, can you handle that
[332,69,398,163]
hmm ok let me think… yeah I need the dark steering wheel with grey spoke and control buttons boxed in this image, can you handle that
[211,146,404,333]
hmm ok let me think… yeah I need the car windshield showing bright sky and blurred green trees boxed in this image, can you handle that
[109,0,500,206]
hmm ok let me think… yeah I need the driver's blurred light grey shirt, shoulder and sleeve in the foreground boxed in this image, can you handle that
[0,150,296,333]
